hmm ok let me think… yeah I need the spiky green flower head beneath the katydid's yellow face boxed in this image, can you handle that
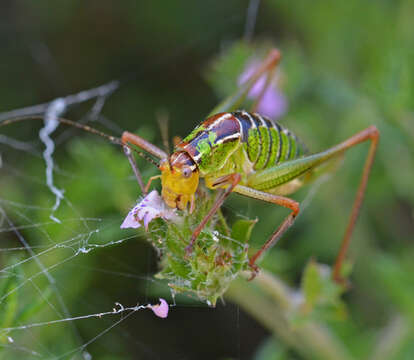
[148,194,255,306]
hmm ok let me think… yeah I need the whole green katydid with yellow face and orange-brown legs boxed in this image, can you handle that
[0,49,379,282]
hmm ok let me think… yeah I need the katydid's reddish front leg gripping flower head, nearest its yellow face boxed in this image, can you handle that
[185,174,241,256]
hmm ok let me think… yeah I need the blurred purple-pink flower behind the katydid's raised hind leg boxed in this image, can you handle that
[239,60,287,119]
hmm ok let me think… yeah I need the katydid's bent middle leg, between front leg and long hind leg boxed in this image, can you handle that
[234,185,300,280]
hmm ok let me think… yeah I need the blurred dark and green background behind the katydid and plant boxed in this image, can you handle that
[0,0,414,360]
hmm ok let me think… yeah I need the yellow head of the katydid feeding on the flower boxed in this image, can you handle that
[160,151,199,212]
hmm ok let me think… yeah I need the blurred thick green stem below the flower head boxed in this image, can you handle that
[226,271,352,360]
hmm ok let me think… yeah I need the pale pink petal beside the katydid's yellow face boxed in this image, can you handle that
[121,190,176,231]
